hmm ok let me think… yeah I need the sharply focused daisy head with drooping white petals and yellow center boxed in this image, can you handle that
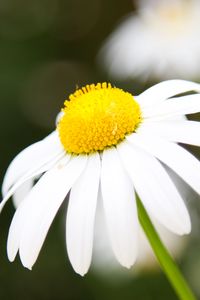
[0,80,200,275]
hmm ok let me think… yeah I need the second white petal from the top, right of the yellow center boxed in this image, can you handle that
[142,94,200,119]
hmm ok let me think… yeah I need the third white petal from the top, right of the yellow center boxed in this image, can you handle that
[137,120,200,146]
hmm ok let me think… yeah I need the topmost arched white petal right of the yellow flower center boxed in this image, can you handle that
[138,79,200,107]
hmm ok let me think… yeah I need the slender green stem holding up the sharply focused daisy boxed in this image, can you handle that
[137,198,196,300]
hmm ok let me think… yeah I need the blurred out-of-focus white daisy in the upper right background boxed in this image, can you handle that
[99,0,200,80]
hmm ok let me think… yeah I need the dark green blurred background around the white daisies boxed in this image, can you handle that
[0,0,200,300]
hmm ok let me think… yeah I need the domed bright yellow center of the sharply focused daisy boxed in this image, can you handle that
[58,83,141,154]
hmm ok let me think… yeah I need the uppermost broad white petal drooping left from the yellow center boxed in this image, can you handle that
[2,131,63,196]
